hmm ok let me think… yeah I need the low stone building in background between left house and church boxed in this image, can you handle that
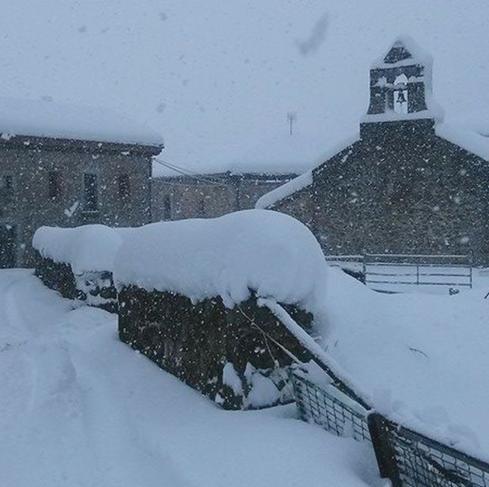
[152,171,296,221]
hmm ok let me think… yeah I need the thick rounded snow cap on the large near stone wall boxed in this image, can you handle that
[114,210,326,310]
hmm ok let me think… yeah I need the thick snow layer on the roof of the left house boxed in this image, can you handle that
[0,98,163,146]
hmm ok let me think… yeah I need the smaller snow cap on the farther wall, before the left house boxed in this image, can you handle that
[32,225,129,274]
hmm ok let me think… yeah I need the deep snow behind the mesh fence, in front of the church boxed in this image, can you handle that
[317,269,489,460]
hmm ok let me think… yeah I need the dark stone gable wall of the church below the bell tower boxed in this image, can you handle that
[275,121,489,265]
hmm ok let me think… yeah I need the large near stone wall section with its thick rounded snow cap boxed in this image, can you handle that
[114,210,326,409]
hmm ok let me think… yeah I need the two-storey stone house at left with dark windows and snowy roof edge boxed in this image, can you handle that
[0,100,162,268]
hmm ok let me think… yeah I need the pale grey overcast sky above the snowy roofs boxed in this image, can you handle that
[0,0,489,175]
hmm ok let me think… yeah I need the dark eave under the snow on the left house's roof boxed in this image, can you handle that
[0,133,164,156]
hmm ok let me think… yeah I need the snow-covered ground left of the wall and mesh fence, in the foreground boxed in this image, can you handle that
[0,270,381,487]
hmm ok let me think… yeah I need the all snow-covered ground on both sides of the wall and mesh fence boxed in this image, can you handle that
[0,269,489,487]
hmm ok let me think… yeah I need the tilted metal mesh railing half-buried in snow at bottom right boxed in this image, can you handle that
[291,369,489,487]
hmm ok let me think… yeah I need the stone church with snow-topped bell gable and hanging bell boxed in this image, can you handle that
[257,38,489,264]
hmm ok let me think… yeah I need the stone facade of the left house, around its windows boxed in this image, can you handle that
[0,136,156,267]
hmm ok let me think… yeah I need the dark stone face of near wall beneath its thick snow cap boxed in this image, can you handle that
[119,286,311,409]
